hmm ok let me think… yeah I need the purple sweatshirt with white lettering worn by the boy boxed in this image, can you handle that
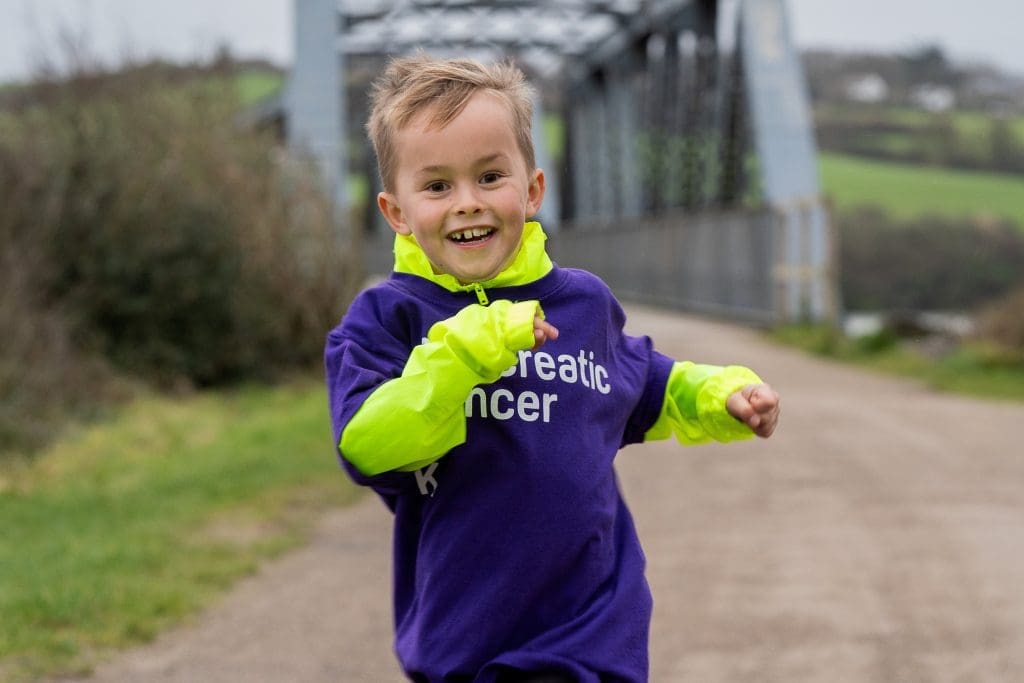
[326,266,673,683]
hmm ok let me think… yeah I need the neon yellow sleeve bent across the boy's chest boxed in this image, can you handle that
[338,300,542,476]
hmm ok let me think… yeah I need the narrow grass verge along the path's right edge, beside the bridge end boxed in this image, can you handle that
[769,325,1024,400]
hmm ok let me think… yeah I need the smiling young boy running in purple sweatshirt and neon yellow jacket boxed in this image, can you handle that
[326,56,779,683]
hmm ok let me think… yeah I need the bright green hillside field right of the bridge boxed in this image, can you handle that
[818,154,1024,226]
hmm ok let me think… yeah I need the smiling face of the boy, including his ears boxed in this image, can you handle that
[377,91,544,284]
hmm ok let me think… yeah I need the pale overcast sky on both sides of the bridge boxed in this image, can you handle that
[0,0,1024,81]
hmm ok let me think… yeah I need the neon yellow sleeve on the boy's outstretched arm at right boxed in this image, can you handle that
[644,361,761,445]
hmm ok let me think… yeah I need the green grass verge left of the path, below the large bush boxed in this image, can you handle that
[0,380,356,680]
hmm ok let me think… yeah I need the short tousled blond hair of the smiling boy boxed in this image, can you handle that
[367,54,537,191]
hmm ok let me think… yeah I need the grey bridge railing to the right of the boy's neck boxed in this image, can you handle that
[549,197,838,326]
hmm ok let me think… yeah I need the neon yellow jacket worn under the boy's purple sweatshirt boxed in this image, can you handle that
[338,222,761,476]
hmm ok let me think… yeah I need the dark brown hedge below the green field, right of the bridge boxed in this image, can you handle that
[837,207,1024,310]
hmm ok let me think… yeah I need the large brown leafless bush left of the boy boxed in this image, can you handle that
[0,69,357,454]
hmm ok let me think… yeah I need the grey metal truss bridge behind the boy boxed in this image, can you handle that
[286,0,837,325]
